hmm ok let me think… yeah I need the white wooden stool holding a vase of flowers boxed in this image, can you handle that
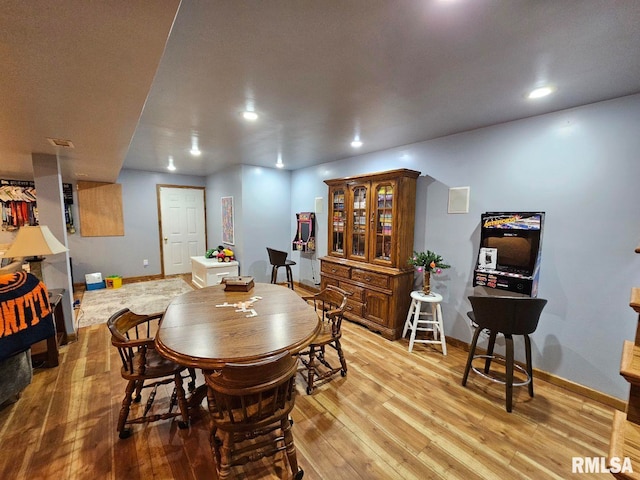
[402,290,447,355]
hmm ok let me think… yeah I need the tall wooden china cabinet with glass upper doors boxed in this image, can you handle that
[320,169,420,340]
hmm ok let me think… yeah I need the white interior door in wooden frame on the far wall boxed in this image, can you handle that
[160,187,206,275]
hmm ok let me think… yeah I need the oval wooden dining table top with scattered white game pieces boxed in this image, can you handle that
[155,283,321,371]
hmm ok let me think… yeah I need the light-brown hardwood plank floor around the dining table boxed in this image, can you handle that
[0,282,613,480]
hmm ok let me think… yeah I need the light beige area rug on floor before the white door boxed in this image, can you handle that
[77,277,193,328]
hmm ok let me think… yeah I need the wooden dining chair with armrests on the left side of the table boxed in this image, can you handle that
[107,308,195,438]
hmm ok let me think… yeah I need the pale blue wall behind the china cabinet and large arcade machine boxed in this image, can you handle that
[292,95,640,399]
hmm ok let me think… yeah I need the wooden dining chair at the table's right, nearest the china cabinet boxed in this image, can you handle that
[297,285,351,394]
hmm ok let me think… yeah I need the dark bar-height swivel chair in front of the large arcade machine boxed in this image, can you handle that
[462,295,547,412]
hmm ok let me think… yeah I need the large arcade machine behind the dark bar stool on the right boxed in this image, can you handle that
[473,212,544,297]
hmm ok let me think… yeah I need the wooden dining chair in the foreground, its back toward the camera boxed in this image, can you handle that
[204,352,304,479]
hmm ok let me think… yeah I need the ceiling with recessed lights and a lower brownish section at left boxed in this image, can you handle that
[0,0,640,181]
